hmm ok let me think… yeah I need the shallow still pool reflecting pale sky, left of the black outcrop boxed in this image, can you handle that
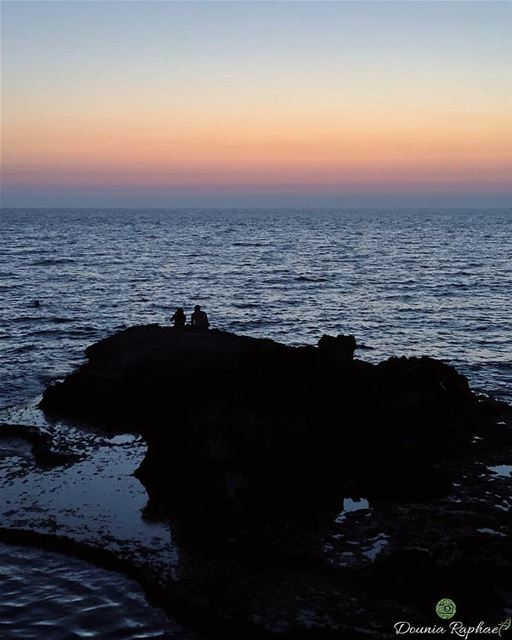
[0,409,178,576]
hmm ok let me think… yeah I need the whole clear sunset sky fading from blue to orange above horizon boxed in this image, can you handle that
[1,0,512,207]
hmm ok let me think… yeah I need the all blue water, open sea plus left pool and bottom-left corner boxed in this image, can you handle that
[0,209,512,640]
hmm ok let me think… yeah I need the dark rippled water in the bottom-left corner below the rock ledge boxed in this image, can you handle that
[0,544,182,640]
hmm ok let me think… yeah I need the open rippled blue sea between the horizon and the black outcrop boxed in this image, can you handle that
[0,209,512,407]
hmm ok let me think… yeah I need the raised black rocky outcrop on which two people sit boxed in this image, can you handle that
[41,326,476,522]
